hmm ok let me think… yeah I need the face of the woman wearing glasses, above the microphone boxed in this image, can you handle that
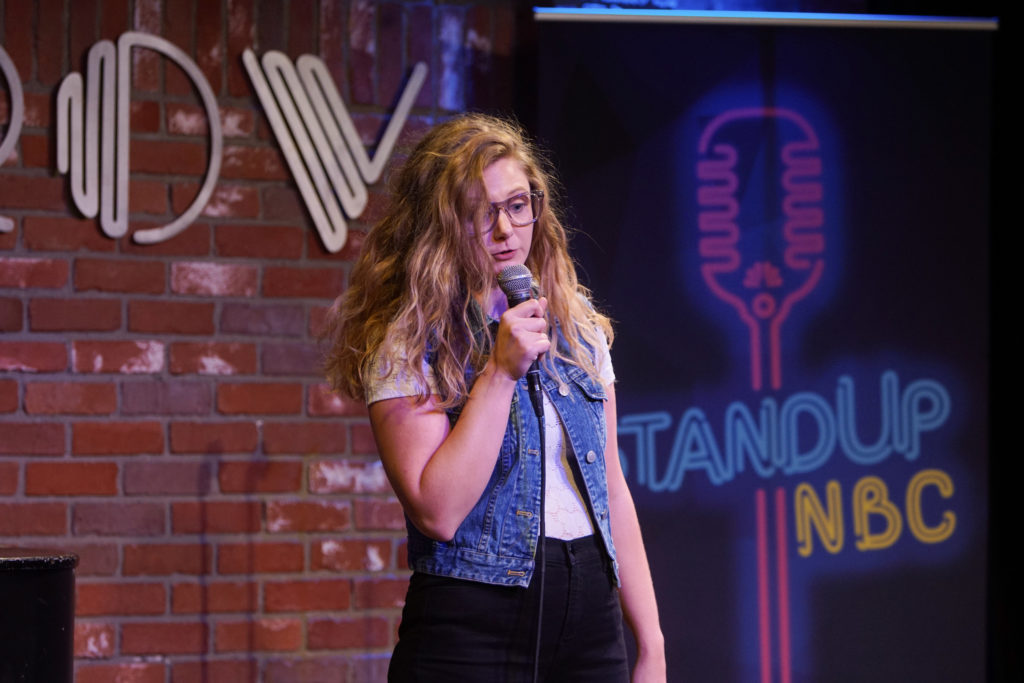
[475,158,534,275]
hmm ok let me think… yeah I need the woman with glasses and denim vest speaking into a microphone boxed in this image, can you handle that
[327,115,665,682]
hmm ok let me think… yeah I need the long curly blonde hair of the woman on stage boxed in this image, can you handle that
[324,114,612,409]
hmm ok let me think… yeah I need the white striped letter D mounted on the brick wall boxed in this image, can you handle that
[56,31,223,244]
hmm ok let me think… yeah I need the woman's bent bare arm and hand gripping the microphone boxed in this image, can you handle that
[370,299,551,541]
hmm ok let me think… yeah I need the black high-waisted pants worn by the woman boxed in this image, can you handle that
[388,536,629,683]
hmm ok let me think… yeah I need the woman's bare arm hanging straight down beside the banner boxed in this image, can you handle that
[604,384,666,683]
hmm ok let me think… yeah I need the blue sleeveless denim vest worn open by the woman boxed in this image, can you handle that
[406,352,618,587]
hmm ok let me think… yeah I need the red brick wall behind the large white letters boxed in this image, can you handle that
[0,0,523,683]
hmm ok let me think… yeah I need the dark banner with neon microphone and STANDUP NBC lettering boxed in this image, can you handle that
[539,17,991,683]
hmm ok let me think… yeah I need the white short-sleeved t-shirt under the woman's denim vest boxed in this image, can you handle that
[365,338,615,541]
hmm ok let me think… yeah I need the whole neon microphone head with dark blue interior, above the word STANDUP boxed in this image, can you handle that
[696,106,825,391]
